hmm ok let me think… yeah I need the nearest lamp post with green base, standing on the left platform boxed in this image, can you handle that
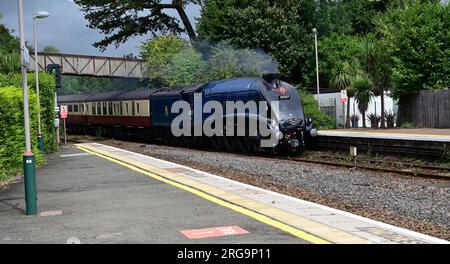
[17,0,37,215]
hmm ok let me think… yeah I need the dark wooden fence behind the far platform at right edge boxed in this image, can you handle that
[397,89,450,128]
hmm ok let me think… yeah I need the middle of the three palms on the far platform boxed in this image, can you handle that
[352,75,374,127]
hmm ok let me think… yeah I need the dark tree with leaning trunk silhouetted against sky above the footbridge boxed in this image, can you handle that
[75,0,202,50]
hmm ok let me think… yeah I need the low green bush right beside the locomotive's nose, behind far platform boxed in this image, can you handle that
[299,89,336,129]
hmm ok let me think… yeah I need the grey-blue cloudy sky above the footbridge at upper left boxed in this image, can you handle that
[0,0,200,56]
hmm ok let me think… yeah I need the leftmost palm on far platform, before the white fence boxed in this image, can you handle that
[330,62,355,127]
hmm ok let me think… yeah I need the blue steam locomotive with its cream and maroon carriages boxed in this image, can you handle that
[58,74,317,153]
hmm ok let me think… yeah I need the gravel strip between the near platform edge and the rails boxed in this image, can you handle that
[84,140,450,240]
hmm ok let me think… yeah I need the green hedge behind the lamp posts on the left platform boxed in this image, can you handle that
[0,73,57,181]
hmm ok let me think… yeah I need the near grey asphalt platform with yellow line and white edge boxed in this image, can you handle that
[0,143,448,244]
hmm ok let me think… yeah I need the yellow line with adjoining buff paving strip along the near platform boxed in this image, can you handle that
[77,145,368,244]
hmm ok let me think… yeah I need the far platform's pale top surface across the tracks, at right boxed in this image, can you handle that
[318,128,450,142]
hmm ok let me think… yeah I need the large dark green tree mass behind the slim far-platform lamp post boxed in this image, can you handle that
[197,0,397,86]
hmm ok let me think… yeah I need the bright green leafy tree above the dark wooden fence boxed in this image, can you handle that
[376,1,450,97]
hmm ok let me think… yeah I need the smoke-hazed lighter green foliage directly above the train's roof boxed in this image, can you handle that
[141,35,276,86]
